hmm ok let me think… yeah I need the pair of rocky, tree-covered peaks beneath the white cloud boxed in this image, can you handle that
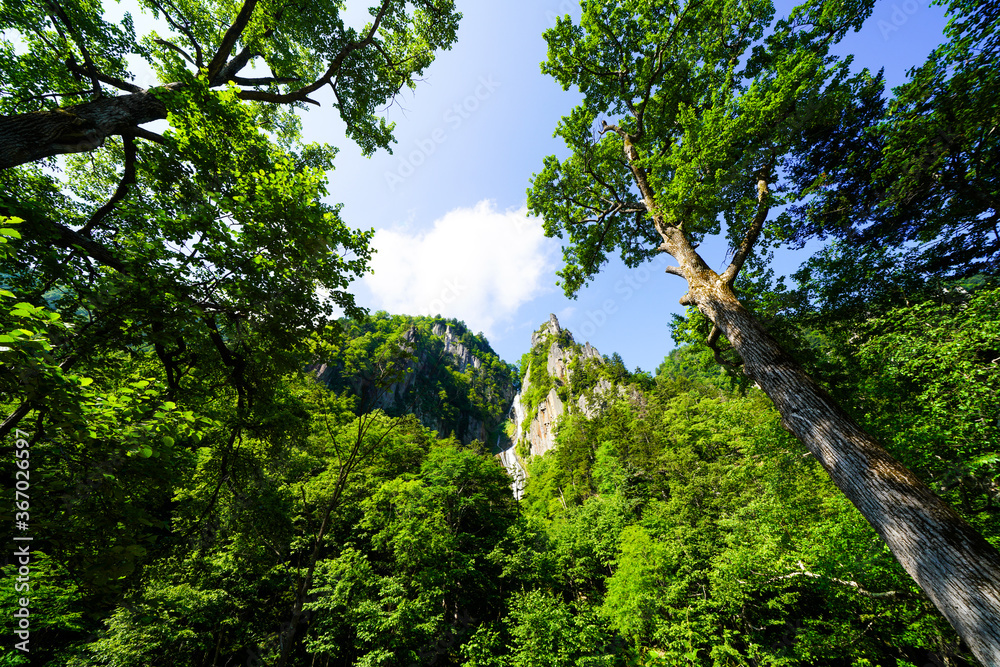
[311,313,642,498]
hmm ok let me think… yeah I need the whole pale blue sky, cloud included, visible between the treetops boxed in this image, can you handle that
[113,0,946,371]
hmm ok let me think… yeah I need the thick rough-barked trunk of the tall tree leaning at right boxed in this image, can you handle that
[675,266,1000,666]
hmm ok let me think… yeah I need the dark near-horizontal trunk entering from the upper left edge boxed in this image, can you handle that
[0,90,168,169]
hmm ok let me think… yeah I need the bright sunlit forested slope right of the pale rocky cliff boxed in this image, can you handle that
[490,300,1000,667]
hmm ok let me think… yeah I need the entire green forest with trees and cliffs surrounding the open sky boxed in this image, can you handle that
[0,0,1000,667]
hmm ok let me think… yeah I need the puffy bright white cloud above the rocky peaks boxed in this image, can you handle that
[363,200,559,334]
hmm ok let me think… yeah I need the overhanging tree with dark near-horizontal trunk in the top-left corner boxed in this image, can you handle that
[0,0,459,169]
